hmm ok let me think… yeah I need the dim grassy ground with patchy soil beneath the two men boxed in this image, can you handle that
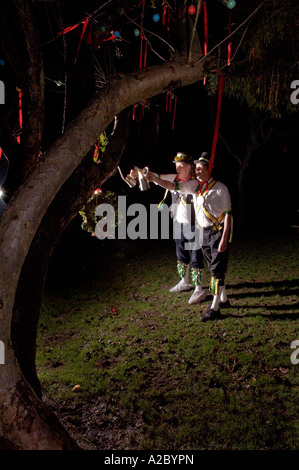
[37,229,299,450]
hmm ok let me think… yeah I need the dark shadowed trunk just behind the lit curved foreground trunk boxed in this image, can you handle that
[11,110,129,396]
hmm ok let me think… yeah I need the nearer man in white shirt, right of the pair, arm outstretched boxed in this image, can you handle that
[148,152,231,321]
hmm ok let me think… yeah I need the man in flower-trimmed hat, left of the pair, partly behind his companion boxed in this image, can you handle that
[130,152,207,305]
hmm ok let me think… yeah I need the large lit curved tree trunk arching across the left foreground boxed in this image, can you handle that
[0,51,210,450]
